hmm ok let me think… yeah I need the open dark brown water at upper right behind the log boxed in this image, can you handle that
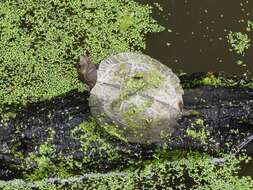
[139,0,253,76]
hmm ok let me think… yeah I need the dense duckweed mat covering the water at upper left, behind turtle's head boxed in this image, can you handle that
[0,0,162,107]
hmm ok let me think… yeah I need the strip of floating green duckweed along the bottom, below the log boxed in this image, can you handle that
[0,151,253,190]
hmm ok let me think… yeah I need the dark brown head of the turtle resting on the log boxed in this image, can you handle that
[77,56,97,90]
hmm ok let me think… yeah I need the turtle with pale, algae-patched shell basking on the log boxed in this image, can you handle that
[79,52,184,144]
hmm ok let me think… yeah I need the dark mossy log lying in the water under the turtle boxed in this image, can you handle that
[0,74,253,179]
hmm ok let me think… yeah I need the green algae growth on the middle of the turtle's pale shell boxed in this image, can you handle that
[105,61,165,141]
